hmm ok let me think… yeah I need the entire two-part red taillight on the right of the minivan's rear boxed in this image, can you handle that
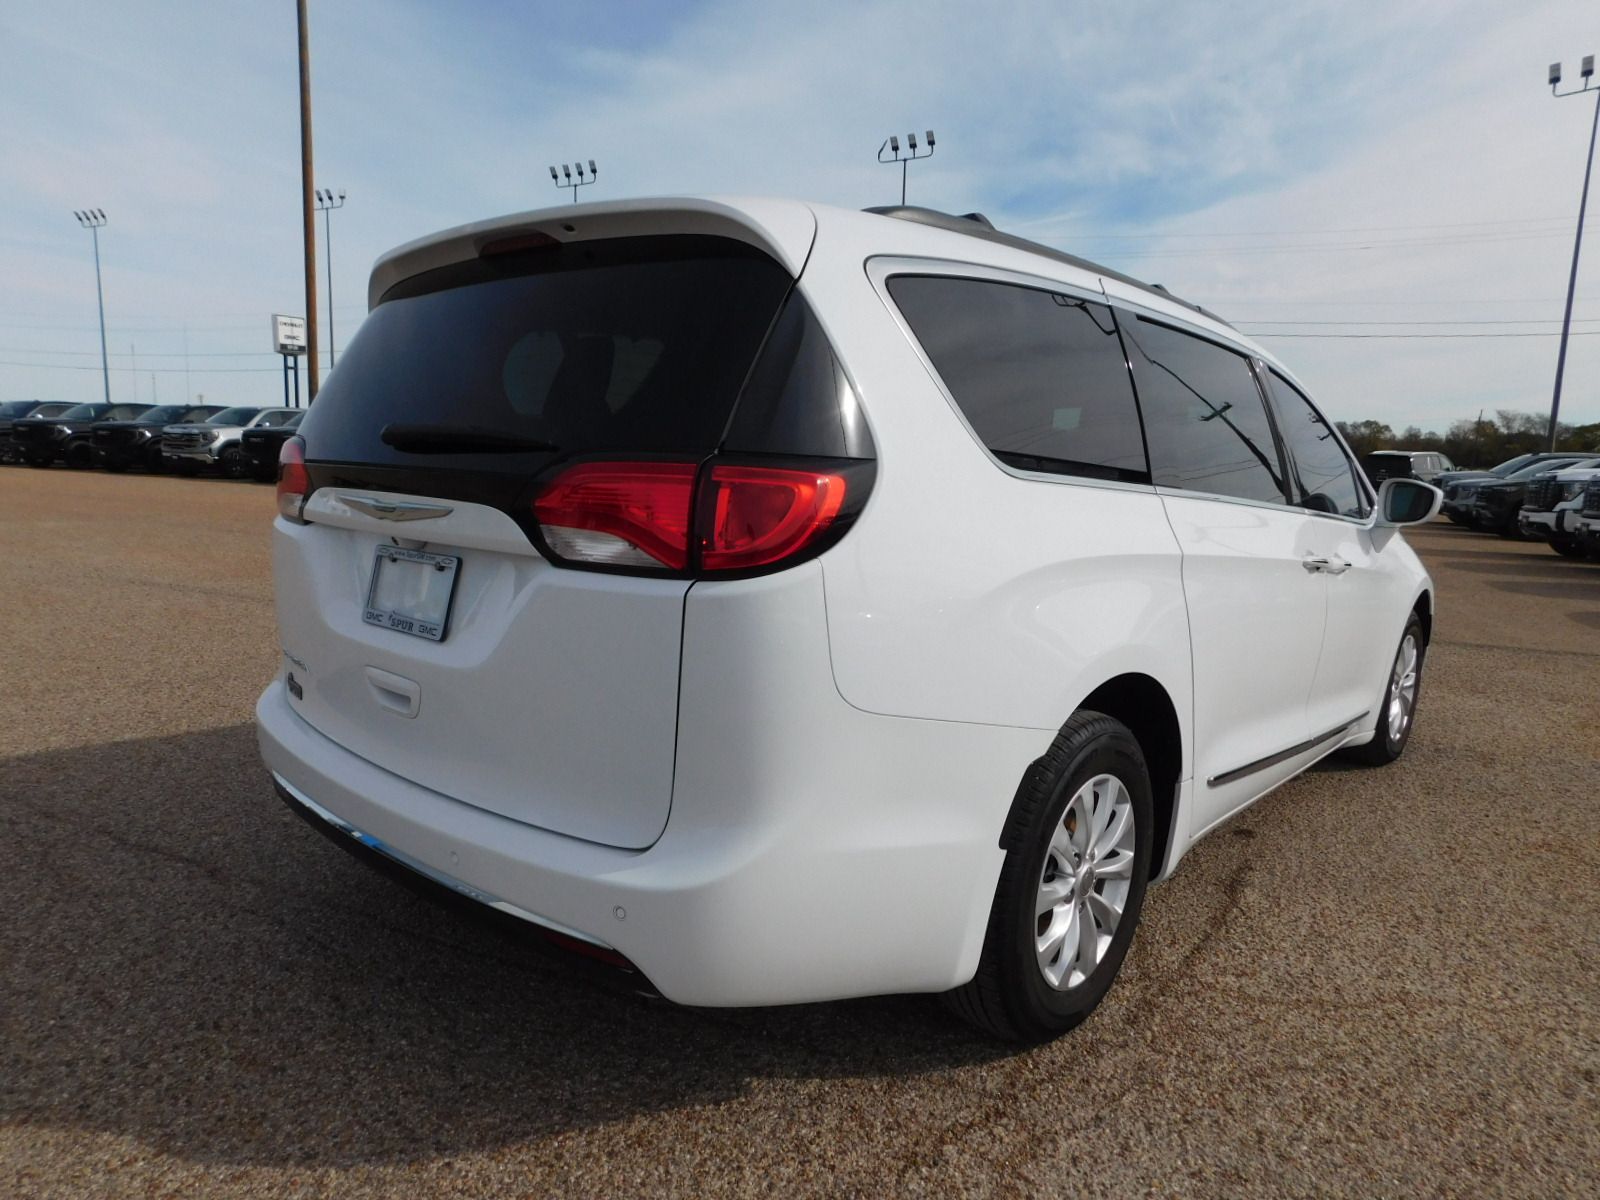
[533,462,859,573]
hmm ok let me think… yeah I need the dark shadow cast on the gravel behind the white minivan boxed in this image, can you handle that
[0,725,1010,1166]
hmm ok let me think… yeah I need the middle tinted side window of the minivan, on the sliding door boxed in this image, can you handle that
[1122,315,1286,504]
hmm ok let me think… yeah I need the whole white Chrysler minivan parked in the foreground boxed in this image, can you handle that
[256,198,1438,1040]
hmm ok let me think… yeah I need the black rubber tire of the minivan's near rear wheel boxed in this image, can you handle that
[944,712,1155,1042]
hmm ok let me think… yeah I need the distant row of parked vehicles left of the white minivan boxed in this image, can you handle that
[0,400,306,482]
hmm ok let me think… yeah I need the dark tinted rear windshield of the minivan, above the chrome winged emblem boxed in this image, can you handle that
[301,237,792,470]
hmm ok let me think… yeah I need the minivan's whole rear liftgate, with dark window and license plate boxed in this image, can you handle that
[275,224,803,848]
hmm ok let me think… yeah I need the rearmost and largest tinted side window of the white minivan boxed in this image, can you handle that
[888,275,1150,483]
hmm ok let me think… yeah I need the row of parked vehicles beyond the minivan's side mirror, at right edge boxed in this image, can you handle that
[1363,450,1600,560]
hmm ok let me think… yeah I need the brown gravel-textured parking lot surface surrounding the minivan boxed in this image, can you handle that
[0,467,1600,1197]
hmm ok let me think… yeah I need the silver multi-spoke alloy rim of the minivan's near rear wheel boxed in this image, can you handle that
[1034,774,1139,990]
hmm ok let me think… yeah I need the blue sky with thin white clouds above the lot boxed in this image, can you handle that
[0,0,1600,427]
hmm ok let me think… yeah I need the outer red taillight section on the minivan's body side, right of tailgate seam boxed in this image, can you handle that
[699,466,845,571]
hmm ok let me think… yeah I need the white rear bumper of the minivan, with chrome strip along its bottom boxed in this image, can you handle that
[256,614,1030,1006]
